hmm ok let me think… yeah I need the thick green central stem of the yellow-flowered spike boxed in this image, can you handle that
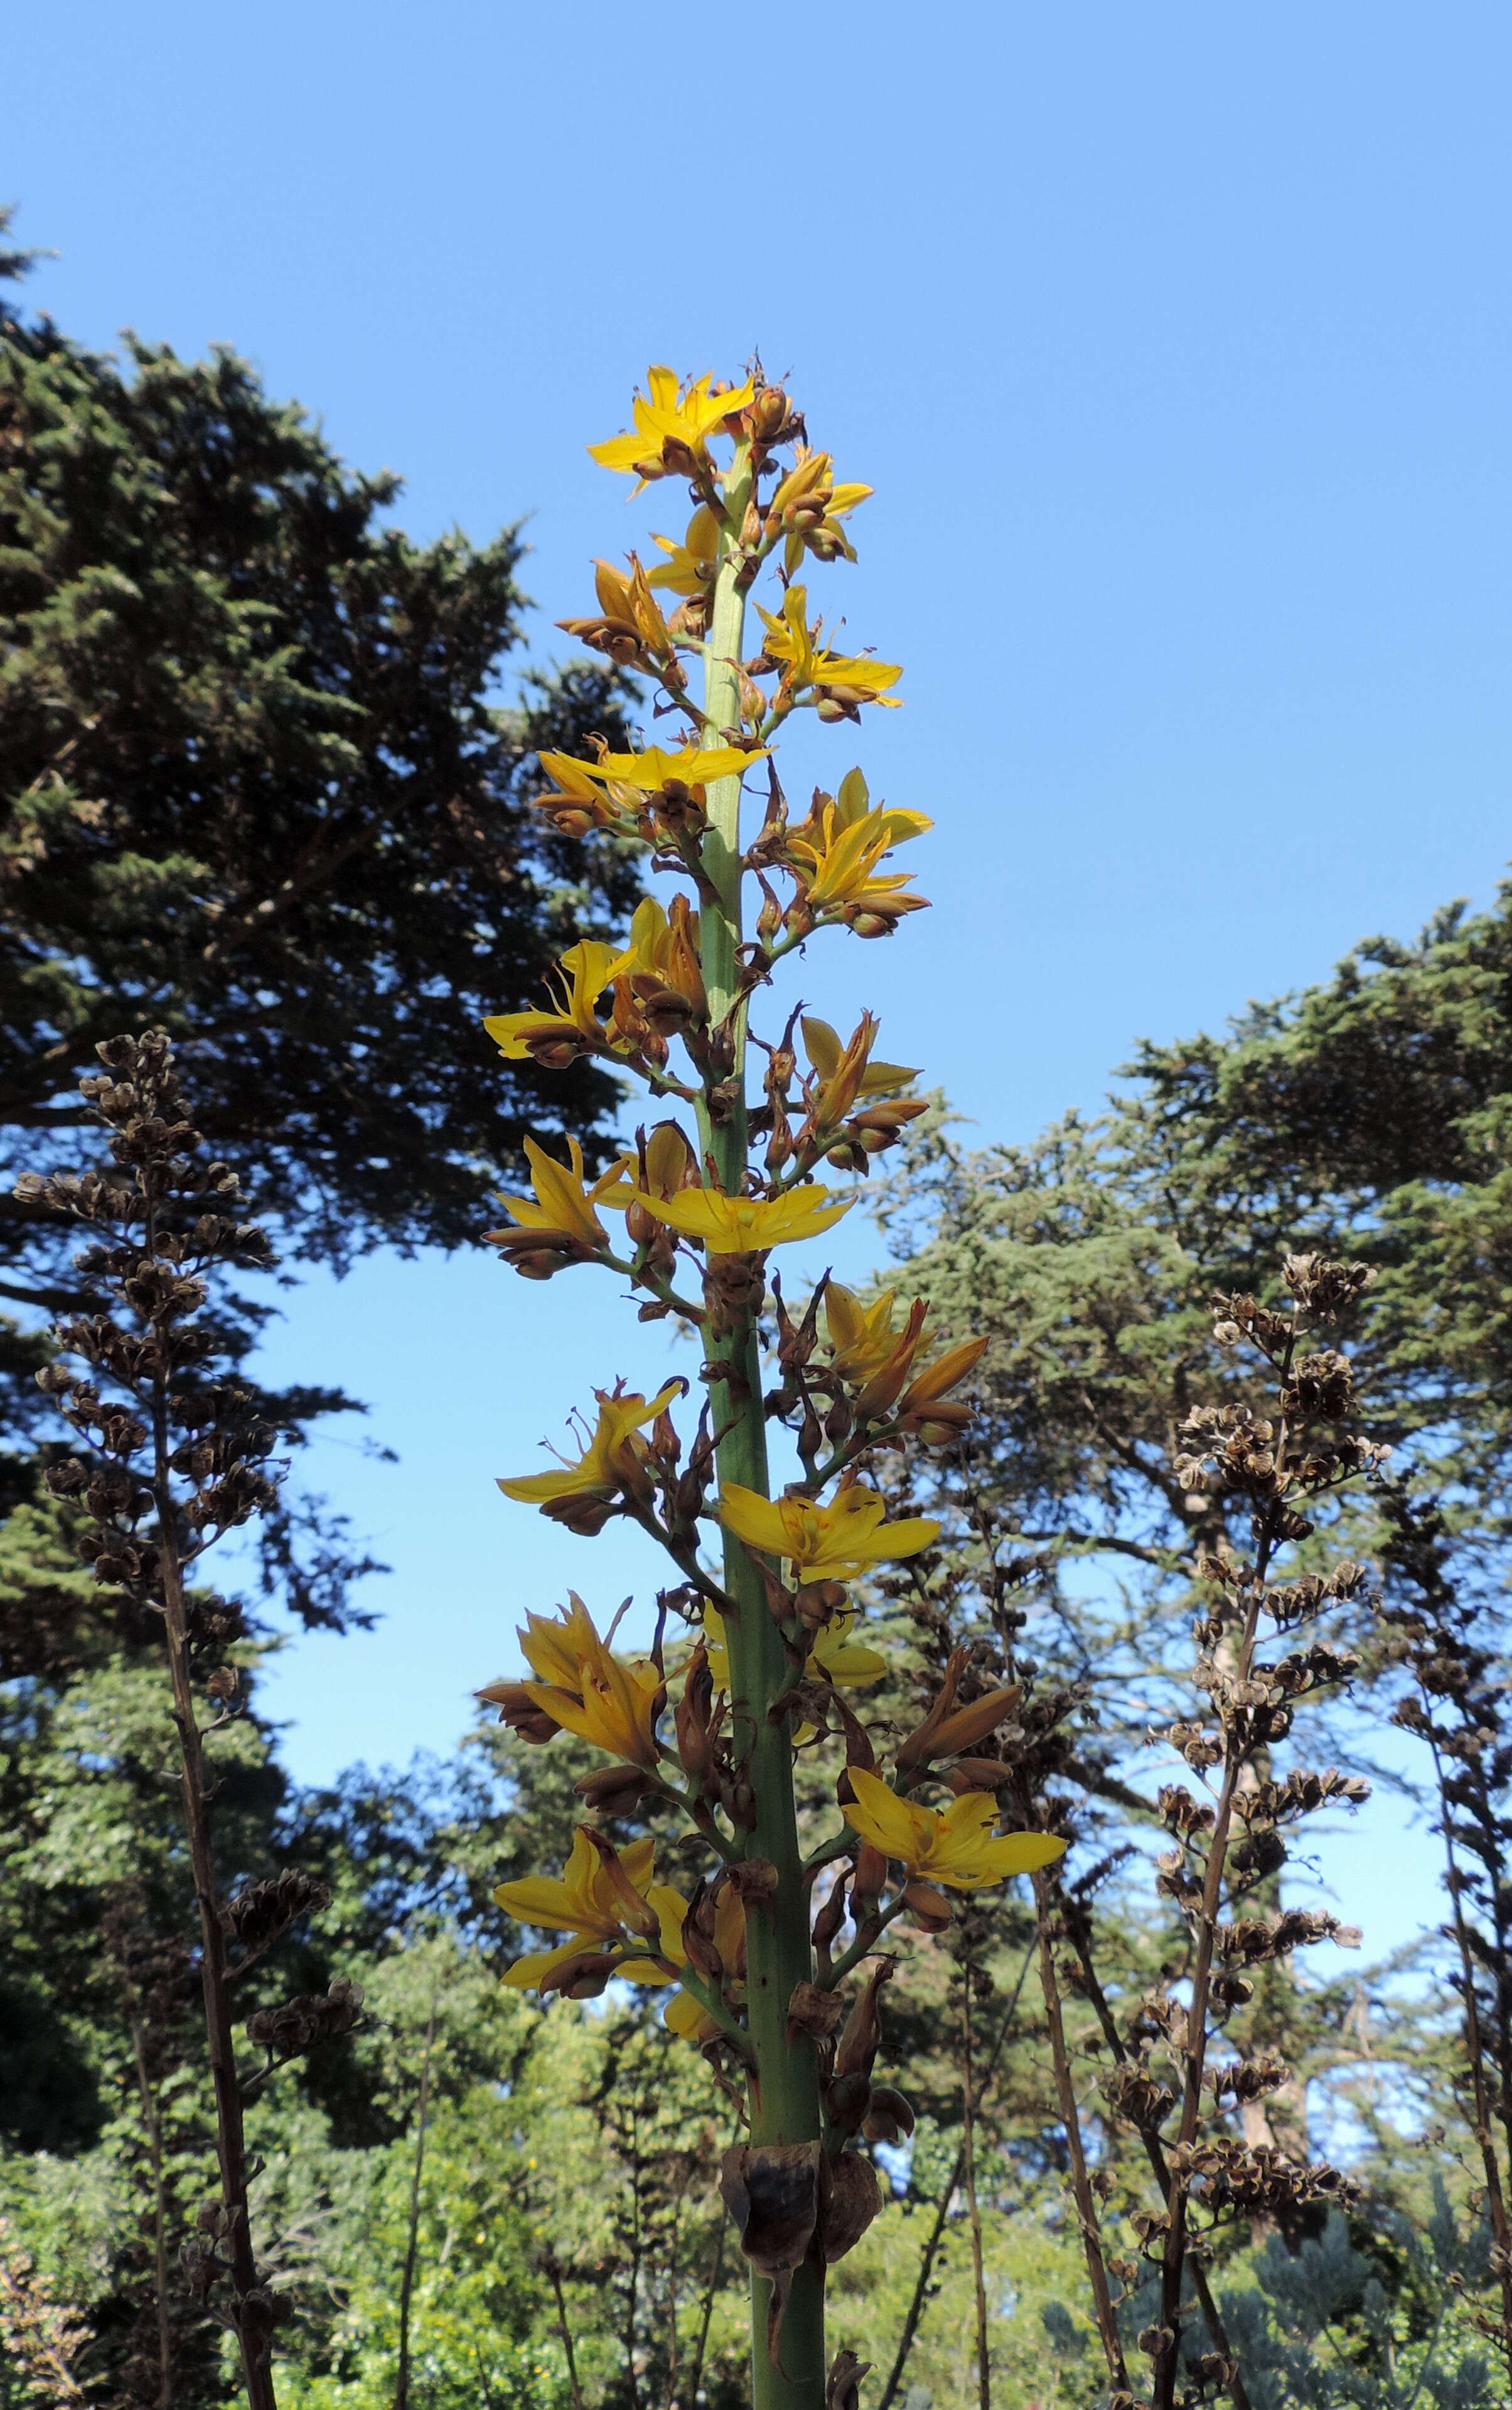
[698,446,826,2410]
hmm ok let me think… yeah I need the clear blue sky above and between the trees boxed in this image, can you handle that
[11,0,1512,1942]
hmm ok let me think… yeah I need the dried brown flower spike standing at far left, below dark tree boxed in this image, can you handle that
[17,1031,361,2410]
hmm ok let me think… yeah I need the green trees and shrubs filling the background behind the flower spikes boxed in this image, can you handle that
[0,235,1512,2410]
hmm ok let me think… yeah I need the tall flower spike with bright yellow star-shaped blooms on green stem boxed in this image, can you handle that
[469,367,992,2410]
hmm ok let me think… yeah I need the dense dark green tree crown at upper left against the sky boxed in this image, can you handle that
[0,226,633,1446]
